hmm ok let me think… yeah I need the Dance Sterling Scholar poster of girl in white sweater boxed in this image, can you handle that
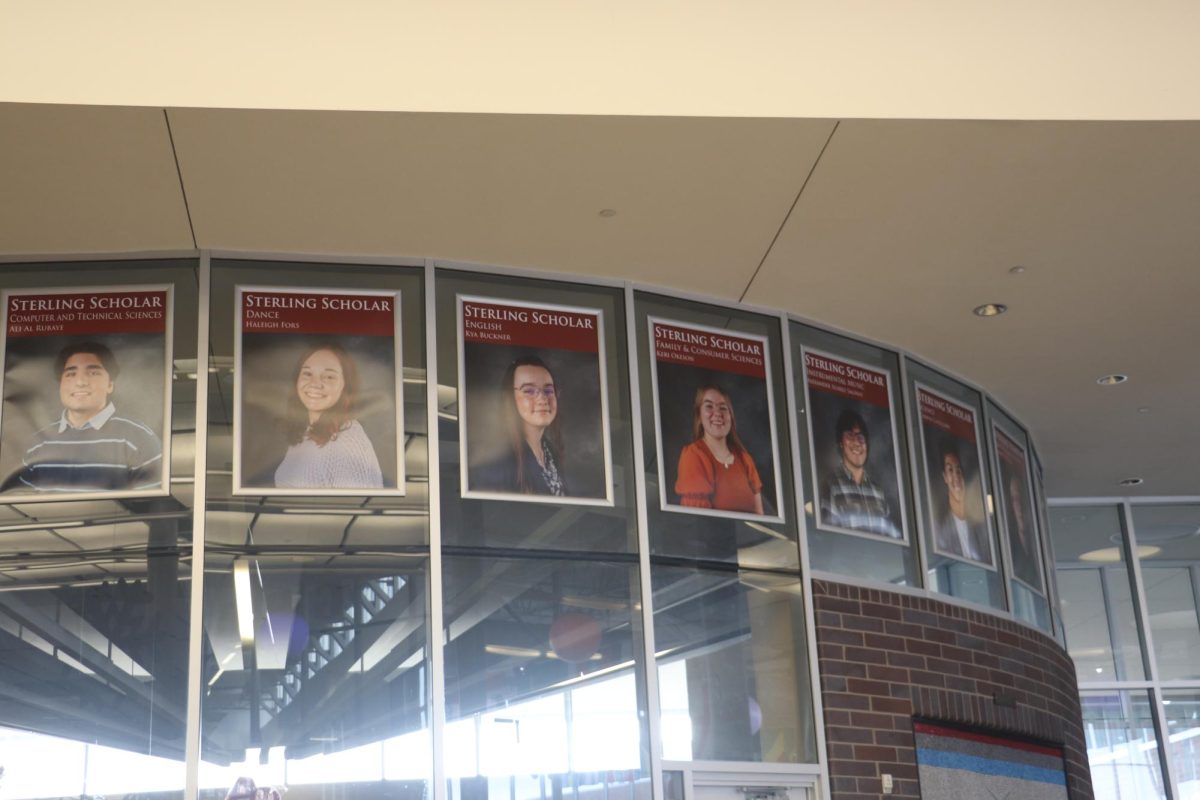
[233,287,404,497]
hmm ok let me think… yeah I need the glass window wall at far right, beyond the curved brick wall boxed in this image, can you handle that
[1050,498,1200,800]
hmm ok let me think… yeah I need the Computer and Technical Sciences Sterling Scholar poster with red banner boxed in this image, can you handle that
[0,285,174,503]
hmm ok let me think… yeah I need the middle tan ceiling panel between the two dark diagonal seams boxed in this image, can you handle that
[170,109,832,297]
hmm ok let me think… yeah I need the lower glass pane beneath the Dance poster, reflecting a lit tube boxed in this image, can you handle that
[200,547,431,796]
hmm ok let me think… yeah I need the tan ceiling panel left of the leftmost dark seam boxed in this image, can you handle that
[0,103,193,255]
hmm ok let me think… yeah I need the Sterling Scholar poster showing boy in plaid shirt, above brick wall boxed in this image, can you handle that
[803,348,908,545]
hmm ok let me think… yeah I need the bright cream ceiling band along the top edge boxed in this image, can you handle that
[0,0,1200,120]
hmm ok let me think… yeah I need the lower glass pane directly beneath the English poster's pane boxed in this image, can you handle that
[443,553,648,798]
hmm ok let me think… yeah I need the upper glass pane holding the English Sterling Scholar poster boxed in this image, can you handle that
[437,270,637,553]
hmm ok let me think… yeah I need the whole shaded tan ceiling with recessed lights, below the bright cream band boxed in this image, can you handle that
[0,104,1200,495]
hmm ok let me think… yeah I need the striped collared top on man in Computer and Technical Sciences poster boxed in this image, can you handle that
[20,403,162,493]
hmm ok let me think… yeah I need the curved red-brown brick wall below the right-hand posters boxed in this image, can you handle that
[812,581,1092,800]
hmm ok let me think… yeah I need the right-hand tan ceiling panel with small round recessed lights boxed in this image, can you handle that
[746,121,1200,495]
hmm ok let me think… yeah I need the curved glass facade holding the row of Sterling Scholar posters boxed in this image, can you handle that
[0,254,1065,800]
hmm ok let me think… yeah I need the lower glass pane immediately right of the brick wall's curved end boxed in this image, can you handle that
[1080,692,1168,800]
